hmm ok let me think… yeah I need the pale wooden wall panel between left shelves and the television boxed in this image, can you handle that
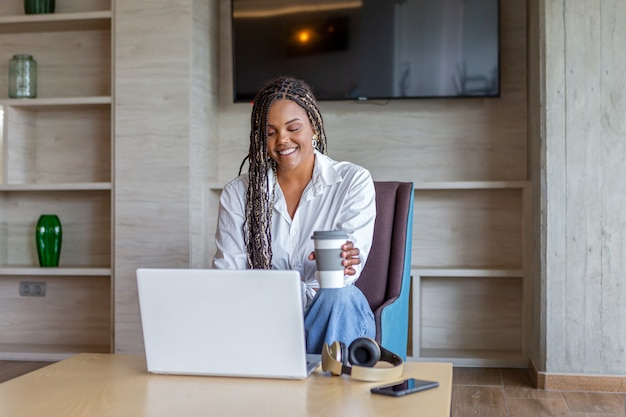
[114,0,218,352]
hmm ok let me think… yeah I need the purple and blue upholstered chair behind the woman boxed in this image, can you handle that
[356,181,413,359]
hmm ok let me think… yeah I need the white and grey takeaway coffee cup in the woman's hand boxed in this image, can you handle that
[311,230,348,288]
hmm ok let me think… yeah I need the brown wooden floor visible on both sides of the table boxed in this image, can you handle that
[0,361,626,417]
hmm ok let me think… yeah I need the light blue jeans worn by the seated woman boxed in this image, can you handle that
[304,285,376,353]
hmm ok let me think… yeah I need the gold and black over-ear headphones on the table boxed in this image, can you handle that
[322,337,404,382]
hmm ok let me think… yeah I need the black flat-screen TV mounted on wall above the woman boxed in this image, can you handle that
[232,0,500,102]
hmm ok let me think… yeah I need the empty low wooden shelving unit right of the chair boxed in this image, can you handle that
[411,181,531,367]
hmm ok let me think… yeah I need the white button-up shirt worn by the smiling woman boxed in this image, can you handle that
[213,151,376,306]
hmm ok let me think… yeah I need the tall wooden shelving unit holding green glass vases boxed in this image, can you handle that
[0,0,113,360]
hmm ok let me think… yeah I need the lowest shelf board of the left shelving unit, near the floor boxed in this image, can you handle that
[0,343,111,362]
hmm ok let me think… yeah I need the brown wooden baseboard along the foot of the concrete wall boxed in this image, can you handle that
[528,358,626,392]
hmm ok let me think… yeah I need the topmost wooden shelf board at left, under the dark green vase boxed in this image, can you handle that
[0,11,112,33]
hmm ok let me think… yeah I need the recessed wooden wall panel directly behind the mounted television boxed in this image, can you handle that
[214,0,527,181]
